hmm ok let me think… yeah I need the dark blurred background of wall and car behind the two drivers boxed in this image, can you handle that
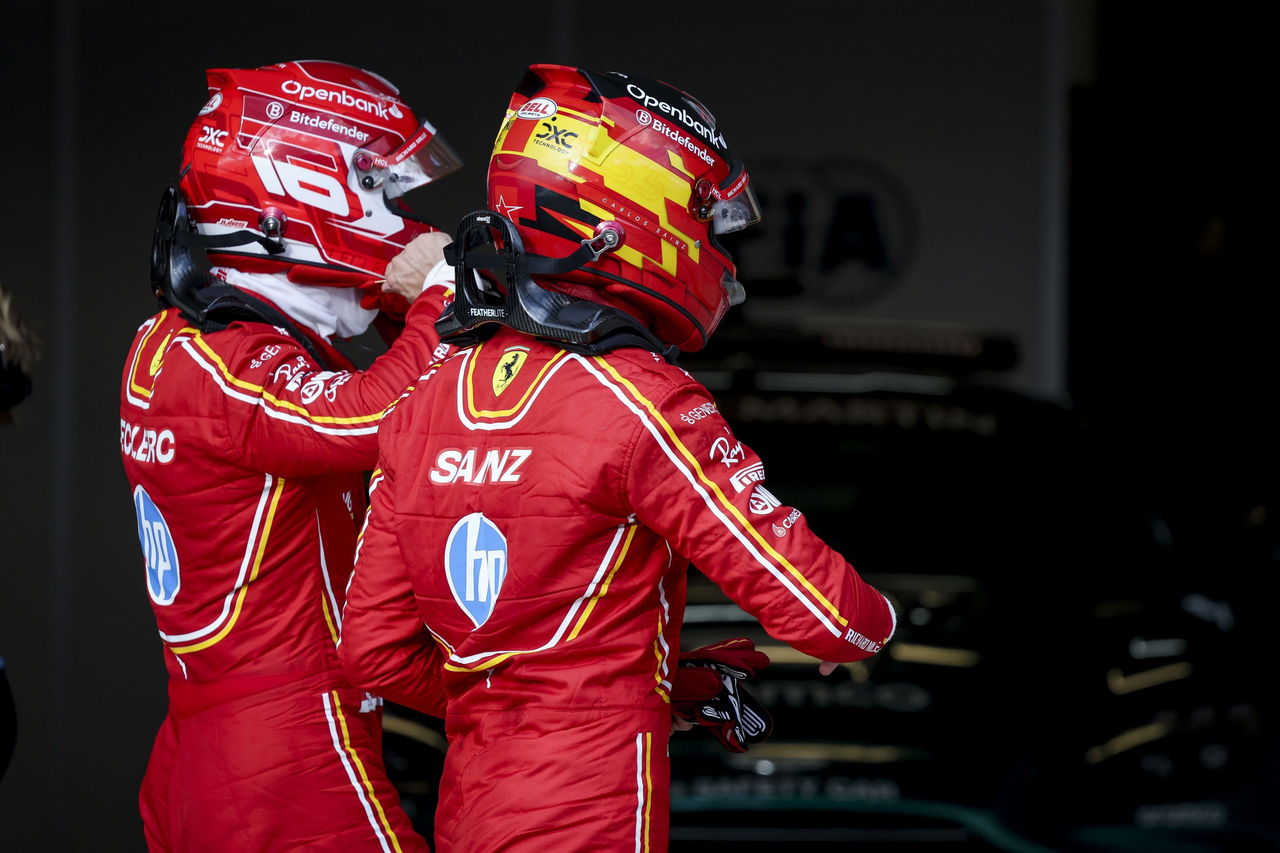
[0,0,1280,850]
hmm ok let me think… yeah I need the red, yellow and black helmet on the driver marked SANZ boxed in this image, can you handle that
[489,65,760,351]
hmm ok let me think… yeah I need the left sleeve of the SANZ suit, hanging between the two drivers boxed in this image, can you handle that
[338,458,445,717]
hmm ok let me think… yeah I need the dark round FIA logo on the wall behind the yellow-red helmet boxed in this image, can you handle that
[721,158,918,307]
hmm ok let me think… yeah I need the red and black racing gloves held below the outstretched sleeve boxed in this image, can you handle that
[671,637,773,752]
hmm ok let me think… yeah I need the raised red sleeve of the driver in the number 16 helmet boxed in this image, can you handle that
[183,292,453,476]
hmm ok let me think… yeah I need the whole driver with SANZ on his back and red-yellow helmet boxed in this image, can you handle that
[340,65,896,853]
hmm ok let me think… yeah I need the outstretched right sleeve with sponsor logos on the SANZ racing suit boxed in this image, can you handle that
[626,379,896,661]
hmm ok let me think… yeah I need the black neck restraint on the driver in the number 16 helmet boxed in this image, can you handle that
[151,187,334,370]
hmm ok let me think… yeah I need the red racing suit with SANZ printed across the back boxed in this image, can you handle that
[340,329,895,853]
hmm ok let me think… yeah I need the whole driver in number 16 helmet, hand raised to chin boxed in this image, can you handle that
[120,60,460,853]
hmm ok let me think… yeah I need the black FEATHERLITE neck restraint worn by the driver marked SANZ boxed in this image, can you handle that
[435,210,678,364]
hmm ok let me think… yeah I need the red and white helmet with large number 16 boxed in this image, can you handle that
[178,60,461,286]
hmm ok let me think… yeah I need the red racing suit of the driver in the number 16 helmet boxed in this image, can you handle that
[120,291,443,853]
